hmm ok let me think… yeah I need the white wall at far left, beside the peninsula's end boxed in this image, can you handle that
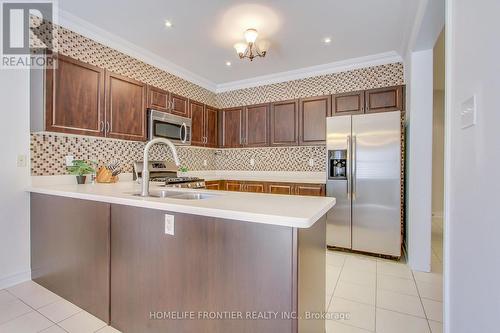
[0,69,30,289]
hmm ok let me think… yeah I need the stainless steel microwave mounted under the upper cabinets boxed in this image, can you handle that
[148,109,191,145]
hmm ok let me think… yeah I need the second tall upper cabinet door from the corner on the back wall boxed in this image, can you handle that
[244,104,269,147]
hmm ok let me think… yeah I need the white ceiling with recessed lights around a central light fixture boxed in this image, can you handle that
[59,0,419,87]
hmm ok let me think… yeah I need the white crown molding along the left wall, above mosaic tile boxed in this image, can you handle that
[58,8,217,93]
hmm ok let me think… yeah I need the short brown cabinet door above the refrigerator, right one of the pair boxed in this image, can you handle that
[365,86,404,113]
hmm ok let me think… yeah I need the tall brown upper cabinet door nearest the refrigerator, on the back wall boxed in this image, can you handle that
[299,96,331,145]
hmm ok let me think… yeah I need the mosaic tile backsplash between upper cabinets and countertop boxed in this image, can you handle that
[31,133,326,176]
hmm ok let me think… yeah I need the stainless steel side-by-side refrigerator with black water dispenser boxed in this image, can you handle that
[326,111,401,257]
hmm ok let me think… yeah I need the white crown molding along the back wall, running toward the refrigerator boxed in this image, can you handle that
[216,51,403,94]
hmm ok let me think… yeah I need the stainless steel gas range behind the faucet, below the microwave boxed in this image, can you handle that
[133,161,205,188]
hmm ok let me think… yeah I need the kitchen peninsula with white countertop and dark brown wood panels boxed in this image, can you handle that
[29,182,335,333]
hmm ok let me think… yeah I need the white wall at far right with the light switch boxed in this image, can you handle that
[444,0,500,333]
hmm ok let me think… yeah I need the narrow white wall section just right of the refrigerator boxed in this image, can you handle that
[407,49,433,271]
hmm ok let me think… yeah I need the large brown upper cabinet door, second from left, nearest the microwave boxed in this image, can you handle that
[106,72,147,141]
